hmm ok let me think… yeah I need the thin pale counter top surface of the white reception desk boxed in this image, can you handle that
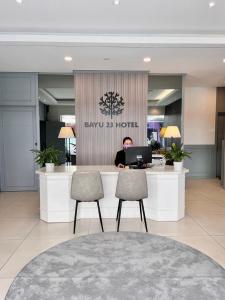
[36,165,189,176]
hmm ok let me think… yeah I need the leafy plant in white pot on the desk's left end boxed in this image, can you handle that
[31,146,61,172]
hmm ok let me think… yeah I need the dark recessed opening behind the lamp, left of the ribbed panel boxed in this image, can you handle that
[38,74,76,165]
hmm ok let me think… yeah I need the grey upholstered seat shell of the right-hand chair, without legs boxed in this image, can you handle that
[116,170,148,201]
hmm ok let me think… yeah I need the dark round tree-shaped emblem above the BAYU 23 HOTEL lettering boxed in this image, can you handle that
[99,92,124,119]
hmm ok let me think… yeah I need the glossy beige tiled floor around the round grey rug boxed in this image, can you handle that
[0,179,225,300]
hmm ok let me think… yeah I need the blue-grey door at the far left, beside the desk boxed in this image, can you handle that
[0,106,37,191]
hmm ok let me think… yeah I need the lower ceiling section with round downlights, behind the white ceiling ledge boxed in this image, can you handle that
[0,45,225,86]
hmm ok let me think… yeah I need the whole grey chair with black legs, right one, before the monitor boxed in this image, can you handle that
[116,170,148,232]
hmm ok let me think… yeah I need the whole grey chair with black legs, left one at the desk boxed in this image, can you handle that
[71,171,104,234]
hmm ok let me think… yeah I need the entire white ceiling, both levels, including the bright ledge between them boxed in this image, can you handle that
[0,0,225,86]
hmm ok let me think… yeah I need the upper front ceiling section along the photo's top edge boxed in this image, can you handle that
[0,0,225,34]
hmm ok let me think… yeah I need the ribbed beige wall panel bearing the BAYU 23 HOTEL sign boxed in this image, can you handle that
[74,71,148,165]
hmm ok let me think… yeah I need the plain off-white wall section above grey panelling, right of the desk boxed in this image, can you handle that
[183,87,216,145]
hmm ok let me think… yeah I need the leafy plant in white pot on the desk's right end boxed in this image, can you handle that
[165,143,191,171]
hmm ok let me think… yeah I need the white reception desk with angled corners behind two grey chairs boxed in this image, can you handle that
[37,166,188,222]
